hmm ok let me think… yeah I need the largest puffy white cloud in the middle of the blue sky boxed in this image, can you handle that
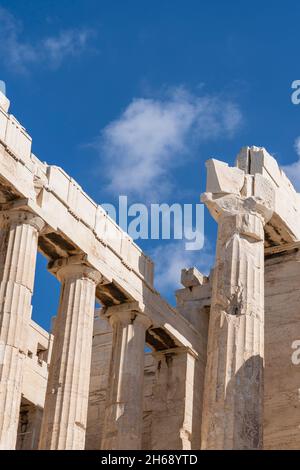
[100,88,242,200]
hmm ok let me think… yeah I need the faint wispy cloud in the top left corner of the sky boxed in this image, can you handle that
[0,6,94,73]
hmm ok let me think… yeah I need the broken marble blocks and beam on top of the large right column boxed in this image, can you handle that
[202,146,300,246]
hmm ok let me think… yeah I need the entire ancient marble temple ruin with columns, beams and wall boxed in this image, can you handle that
[0,89,300,450]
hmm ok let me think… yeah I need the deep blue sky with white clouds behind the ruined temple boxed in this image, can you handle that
[0,0,300,327]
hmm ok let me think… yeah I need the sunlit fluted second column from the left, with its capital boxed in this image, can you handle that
[39,256,101,450]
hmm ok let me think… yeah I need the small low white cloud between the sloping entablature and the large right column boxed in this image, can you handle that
[150,241,214,295]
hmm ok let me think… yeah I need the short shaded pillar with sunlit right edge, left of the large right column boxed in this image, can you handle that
[151,347,201,450]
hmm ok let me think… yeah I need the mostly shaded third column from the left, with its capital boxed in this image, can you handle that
[102,304,151,450]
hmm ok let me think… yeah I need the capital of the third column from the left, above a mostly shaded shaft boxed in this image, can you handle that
[104,302,152,329]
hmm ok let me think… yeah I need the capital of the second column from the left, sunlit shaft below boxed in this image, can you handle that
[48,255,102,285]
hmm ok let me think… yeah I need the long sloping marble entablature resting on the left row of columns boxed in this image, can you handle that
[0,89,203,356]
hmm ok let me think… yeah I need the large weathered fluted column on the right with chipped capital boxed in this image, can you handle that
[202,196,265,449]
